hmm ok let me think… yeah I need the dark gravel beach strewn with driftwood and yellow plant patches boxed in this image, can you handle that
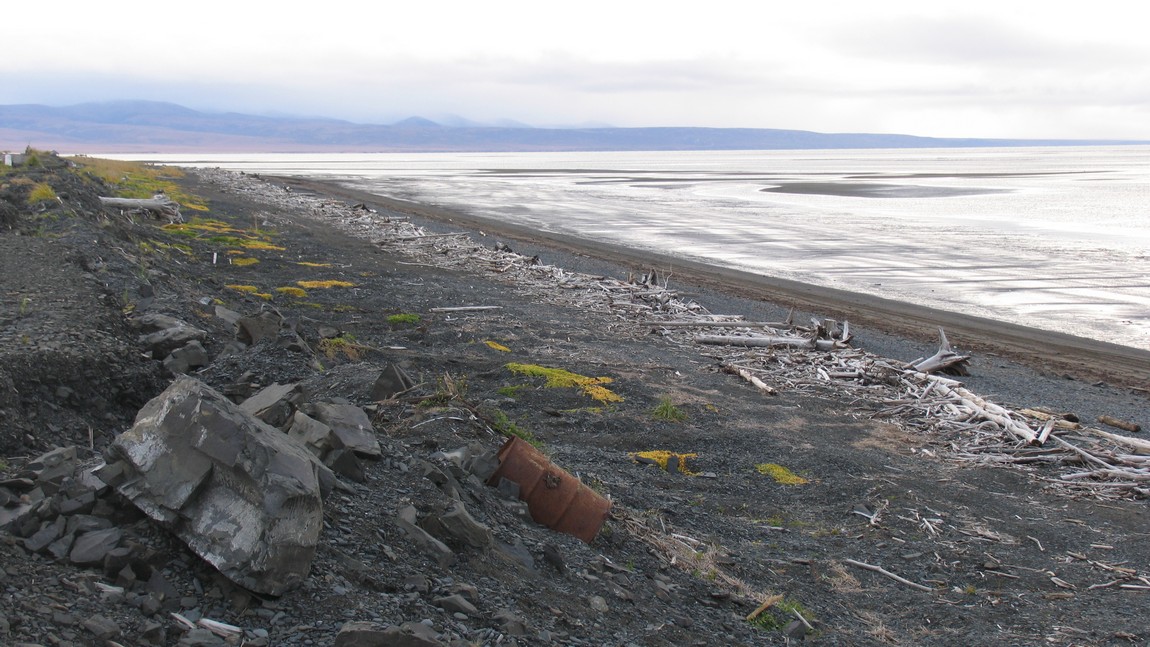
[0,158,1150,647]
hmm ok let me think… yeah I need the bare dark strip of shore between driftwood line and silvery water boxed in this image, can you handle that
[273,175,1150,394]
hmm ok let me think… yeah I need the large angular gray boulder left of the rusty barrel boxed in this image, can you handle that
[108,376,323,595]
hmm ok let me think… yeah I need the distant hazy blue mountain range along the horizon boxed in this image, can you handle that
[0,101,1150,153]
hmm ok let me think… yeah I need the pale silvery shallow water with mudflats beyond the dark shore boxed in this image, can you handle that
[123,146,1150,348]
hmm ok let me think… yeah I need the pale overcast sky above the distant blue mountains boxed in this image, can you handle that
[0,0,1150,139]
